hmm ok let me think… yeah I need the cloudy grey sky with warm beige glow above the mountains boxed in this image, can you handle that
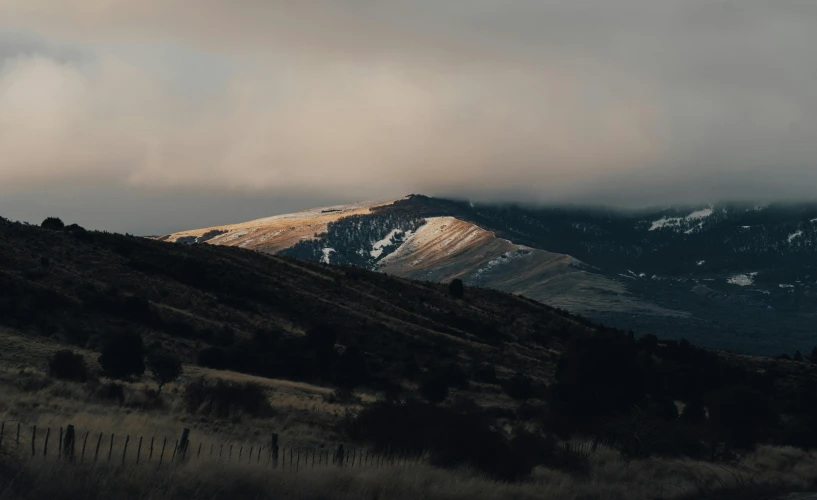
[0,0,817,234]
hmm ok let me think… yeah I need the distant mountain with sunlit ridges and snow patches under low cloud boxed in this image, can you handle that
[161,195,817,354]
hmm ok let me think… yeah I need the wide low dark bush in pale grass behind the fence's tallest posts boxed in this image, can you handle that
[184,378,271,418]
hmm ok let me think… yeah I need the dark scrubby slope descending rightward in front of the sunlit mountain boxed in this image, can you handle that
[0,215,592,386]
